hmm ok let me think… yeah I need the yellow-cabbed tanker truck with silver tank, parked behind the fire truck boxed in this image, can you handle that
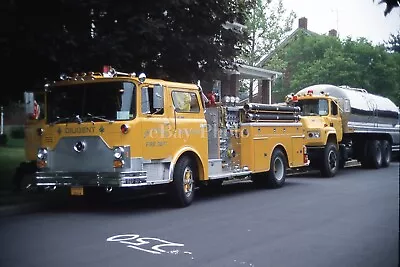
[286,84,399,177]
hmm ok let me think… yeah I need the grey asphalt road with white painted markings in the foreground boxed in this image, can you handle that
[0,163,399,267]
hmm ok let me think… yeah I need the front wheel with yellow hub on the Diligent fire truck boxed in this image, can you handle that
[170,156,196,208]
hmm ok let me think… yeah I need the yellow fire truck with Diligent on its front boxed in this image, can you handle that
[22,67,309,207]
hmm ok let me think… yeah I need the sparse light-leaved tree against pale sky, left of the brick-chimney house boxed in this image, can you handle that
[239,0,296,101]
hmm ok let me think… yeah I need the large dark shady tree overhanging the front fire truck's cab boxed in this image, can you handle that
[0,0,252,104]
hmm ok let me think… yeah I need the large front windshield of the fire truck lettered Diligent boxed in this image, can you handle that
[47,81,136,123]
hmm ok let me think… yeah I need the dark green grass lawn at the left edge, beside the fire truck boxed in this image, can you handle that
[0,139,25,191]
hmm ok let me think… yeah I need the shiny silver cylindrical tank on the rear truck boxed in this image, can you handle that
[296,84,400,146]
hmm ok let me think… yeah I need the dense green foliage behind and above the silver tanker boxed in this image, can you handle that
[268,33,400,105]
